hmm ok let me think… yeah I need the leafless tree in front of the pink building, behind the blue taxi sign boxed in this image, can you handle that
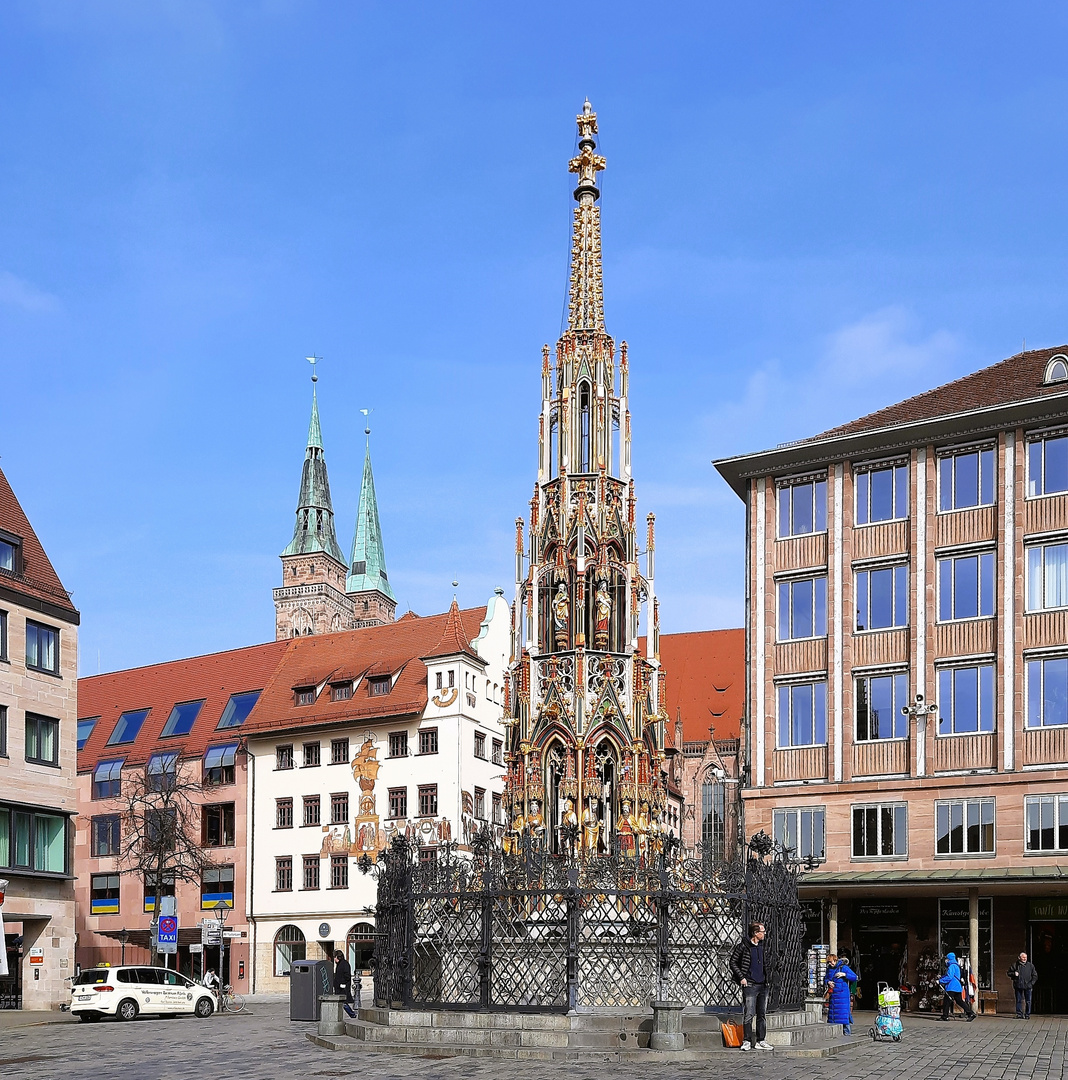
[119,754,212,963]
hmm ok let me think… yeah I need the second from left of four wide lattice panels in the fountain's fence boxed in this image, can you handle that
[490,892,568,1009]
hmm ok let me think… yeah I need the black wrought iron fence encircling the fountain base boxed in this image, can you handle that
[362,829,805,1012]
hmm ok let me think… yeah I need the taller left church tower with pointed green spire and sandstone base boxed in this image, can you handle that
[274,370,353,638]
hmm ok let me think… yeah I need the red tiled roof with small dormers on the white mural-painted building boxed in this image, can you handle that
[241,602,486,735]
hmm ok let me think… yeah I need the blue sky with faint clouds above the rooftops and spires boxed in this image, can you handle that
[0,0,1068,674]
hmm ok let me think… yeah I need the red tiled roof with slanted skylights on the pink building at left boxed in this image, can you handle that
[78,640,290,772]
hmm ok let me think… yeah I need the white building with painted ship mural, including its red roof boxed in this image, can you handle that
[246,590,511,993]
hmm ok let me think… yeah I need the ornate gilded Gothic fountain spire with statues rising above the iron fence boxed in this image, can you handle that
[505,102,667,859]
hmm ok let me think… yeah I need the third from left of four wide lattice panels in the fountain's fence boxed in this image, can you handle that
[578,892,658,1009]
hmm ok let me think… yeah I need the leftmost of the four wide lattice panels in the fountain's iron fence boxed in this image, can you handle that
[411,894,482,1007]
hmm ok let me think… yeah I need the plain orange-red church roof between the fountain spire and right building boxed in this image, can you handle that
[639,630,745,742]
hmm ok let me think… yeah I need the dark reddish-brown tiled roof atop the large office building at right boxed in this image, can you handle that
[816,346,1068,442]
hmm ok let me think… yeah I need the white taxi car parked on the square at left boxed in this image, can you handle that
[70,967,215,1021]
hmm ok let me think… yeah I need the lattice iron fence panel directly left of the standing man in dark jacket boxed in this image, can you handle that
[660,893,744,1005]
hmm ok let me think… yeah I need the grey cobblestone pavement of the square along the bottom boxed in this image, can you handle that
[0,1002,1068,1080]
